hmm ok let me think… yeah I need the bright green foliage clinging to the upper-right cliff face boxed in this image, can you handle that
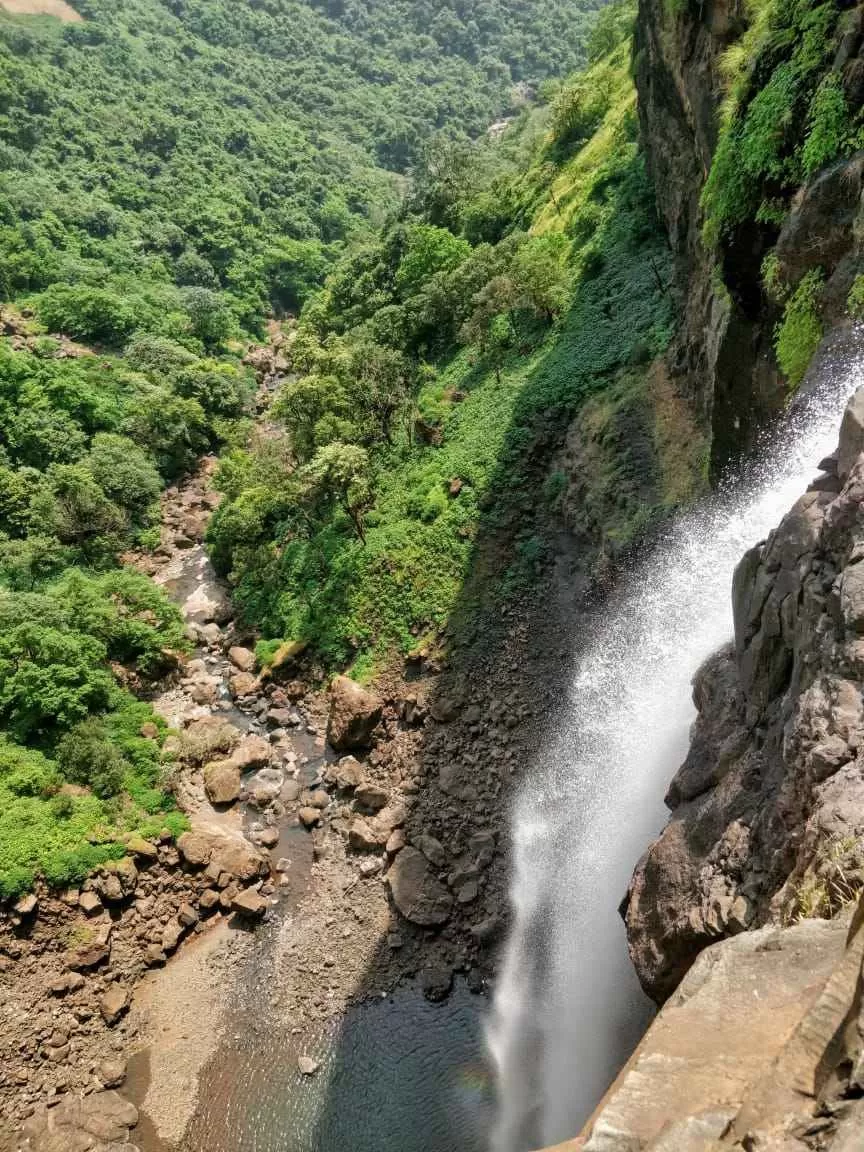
[702,0,864,387]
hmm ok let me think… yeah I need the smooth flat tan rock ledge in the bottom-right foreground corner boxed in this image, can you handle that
[576,902,864,1152]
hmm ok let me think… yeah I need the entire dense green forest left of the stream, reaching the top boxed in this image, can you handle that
[0,0,597,897]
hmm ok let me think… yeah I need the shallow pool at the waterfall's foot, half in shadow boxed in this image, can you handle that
[184,984,492,1152]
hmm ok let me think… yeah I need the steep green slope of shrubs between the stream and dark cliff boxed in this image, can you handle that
[210,18,691,676]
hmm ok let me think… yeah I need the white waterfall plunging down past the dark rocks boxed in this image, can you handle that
[487,344,864,1152]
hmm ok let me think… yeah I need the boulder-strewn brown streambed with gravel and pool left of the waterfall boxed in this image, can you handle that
[0,336,548,1152]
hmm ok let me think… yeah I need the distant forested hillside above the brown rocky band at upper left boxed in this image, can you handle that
[0,0,598,336]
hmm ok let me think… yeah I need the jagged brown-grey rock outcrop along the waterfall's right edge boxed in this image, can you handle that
[624,375,864,1002]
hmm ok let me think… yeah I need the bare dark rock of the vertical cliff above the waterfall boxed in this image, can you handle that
[635,0,864,471]
